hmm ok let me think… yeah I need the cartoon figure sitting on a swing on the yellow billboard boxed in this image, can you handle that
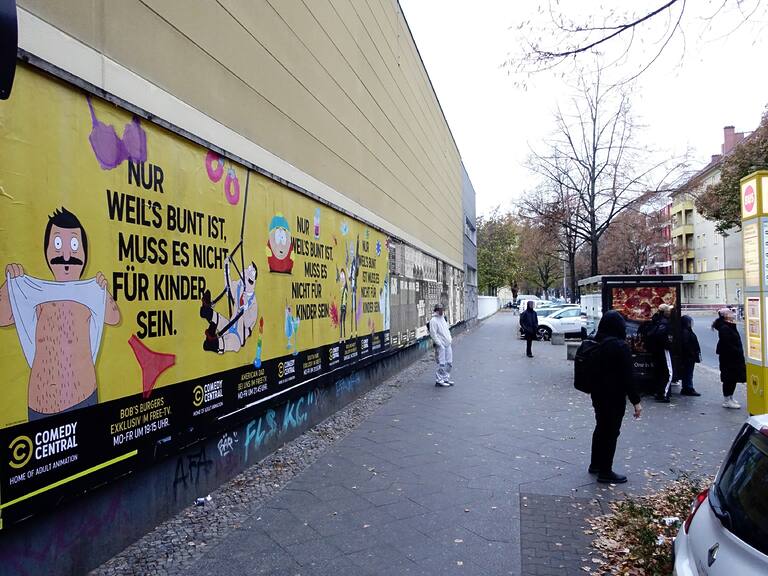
[200,253,259,354]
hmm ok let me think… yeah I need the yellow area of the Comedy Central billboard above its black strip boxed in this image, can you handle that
[0,67,388,426]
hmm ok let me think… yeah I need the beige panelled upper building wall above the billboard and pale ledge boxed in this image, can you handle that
[18,0,463,267]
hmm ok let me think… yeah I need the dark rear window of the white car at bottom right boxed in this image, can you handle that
[717,426,768,554]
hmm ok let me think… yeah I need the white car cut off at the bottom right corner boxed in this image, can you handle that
[674,414,768,576]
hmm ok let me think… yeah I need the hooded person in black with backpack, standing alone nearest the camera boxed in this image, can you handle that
[589,310,642,484]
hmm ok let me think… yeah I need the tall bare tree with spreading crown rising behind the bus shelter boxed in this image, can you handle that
[529,66,683,275]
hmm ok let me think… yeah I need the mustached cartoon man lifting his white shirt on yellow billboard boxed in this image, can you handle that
[0,207,120,420]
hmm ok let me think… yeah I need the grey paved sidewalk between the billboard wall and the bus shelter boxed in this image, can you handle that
[94,313,746,576]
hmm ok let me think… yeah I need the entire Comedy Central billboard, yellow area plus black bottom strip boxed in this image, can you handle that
[0,66,389,525]
